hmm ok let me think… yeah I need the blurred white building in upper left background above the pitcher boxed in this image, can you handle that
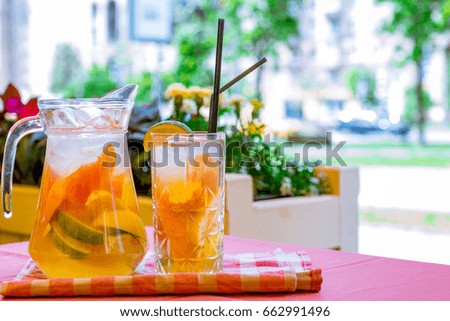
[0,0,175,96]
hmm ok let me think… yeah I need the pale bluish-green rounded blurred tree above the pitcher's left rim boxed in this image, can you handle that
[50,44,82,95]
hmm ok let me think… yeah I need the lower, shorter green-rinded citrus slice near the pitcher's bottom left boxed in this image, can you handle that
[50,223,91,260]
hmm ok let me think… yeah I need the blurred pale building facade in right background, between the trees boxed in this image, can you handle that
[265,0,448,127]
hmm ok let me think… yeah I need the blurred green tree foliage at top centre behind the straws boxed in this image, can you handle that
[174,0,301,96]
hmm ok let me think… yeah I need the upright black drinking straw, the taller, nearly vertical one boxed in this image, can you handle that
[208,19,225,133]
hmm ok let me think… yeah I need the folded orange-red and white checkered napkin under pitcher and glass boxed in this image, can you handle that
[1,249,322,297]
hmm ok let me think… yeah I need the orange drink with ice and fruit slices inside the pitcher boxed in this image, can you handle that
[29,133,147,277]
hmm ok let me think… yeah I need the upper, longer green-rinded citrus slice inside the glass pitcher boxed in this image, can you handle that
[55,211,105,245]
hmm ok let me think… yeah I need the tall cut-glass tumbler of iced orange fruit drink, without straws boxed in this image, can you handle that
[150,133,224,273]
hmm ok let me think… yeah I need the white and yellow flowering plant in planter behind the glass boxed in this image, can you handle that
[165,84,326,198]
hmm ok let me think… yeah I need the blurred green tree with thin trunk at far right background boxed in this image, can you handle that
[377,0,449,144]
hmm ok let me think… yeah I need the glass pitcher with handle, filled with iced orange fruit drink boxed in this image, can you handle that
[2,85,147,277]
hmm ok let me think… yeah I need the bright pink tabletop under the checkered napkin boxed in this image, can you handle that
[0,226,450,301]
